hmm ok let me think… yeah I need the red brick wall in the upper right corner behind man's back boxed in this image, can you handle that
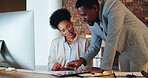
[121,0,148,27]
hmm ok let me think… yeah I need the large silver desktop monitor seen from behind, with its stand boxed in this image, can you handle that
[0,11,35,70]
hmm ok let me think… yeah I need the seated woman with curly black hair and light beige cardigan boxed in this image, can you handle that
[48,9,90,71]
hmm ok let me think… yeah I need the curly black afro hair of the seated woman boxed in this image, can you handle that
[50,9,71,29]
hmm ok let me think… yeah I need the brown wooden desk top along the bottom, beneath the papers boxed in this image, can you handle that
[0,71,114,78]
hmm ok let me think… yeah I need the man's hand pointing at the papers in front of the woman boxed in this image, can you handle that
[66,58,85,70]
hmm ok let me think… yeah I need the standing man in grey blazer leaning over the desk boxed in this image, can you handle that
[67,0,148,72]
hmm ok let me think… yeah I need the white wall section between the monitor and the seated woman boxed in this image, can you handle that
[27,0,62,68]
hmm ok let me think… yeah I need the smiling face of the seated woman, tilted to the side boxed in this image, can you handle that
[58,20,76,38]
